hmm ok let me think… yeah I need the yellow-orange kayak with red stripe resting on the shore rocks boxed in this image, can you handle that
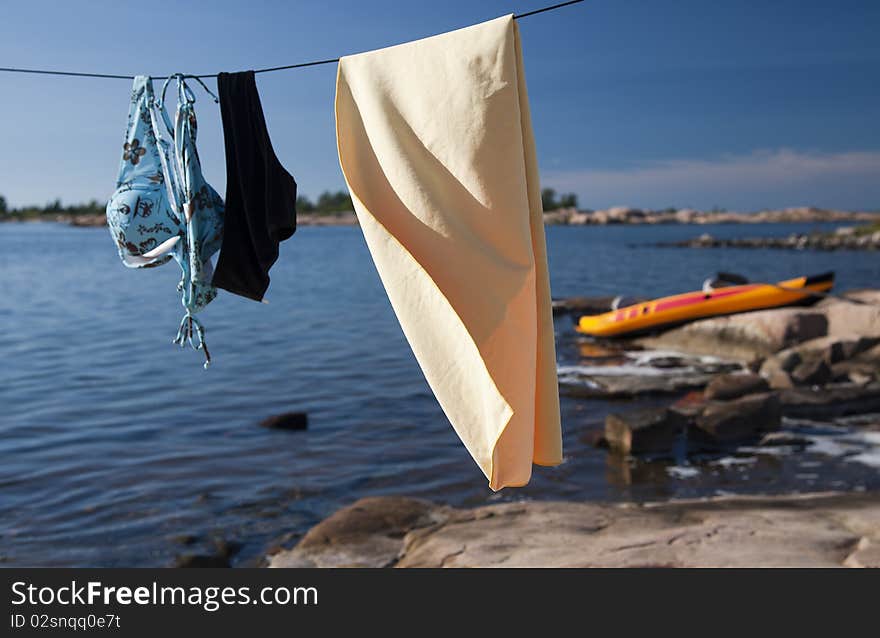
[575,272,834,337]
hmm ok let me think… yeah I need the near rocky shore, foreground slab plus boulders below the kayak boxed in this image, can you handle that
[268,290,880,567]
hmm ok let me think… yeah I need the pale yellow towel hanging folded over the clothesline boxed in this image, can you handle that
[336,16,562,490]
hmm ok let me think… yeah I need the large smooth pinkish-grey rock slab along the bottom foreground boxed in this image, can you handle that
[270,493,880,567]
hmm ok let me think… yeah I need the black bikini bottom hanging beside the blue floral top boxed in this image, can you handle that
[212,71,296,301]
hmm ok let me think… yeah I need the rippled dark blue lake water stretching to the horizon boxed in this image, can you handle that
[0,223,880,566]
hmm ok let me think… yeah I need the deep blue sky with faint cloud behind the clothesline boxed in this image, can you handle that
[0,0,880,210]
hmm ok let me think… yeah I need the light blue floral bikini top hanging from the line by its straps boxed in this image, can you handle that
[107,74,224,368]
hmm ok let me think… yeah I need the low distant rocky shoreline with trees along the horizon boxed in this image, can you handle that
[0,206,880,227]
